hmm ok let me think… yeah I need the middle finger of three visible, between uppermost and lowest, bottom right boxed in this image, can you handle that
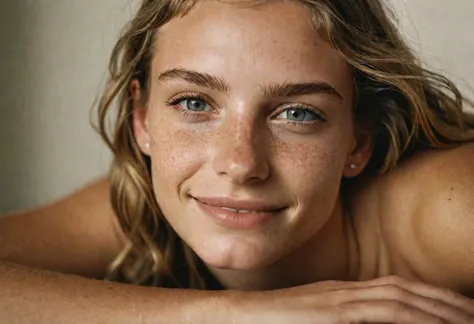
[327,285,473,324]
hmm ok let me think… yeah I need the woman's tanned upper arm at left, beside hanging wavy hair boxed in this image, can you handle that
[0,180,125,277]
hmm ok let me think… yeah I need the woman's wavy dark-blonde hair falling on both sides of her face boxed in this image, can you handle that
[97,0,474,289]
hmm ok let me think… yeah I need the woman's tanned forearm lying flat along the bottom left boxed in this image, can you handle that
[0,262,231,324]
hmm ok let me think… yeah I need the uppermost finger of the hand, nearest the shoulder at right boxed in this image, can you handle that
[366,276,474,316]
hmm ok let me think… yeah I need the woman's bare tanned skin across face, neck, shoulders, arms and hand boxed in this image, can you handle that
[0,2,474,323]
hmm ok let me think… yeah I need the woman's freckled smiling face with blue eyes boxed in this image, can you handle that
[135,1,364,269]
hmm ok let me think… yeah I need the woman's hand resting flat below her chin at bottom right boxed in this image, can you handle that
[236,276,474,324]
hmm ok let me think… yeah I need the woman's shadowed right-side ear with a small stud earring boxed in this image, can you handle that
[343,133,373,178]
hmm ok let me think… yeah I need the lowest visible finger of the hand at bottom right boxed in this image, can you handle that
[335,300,449,324]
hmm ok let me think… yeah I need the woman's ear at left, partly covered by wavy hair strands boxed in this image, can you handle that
[129,79,151,155]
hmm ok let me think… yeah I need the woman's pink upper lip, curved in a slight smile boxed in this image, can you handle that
[193,196,286,212]
